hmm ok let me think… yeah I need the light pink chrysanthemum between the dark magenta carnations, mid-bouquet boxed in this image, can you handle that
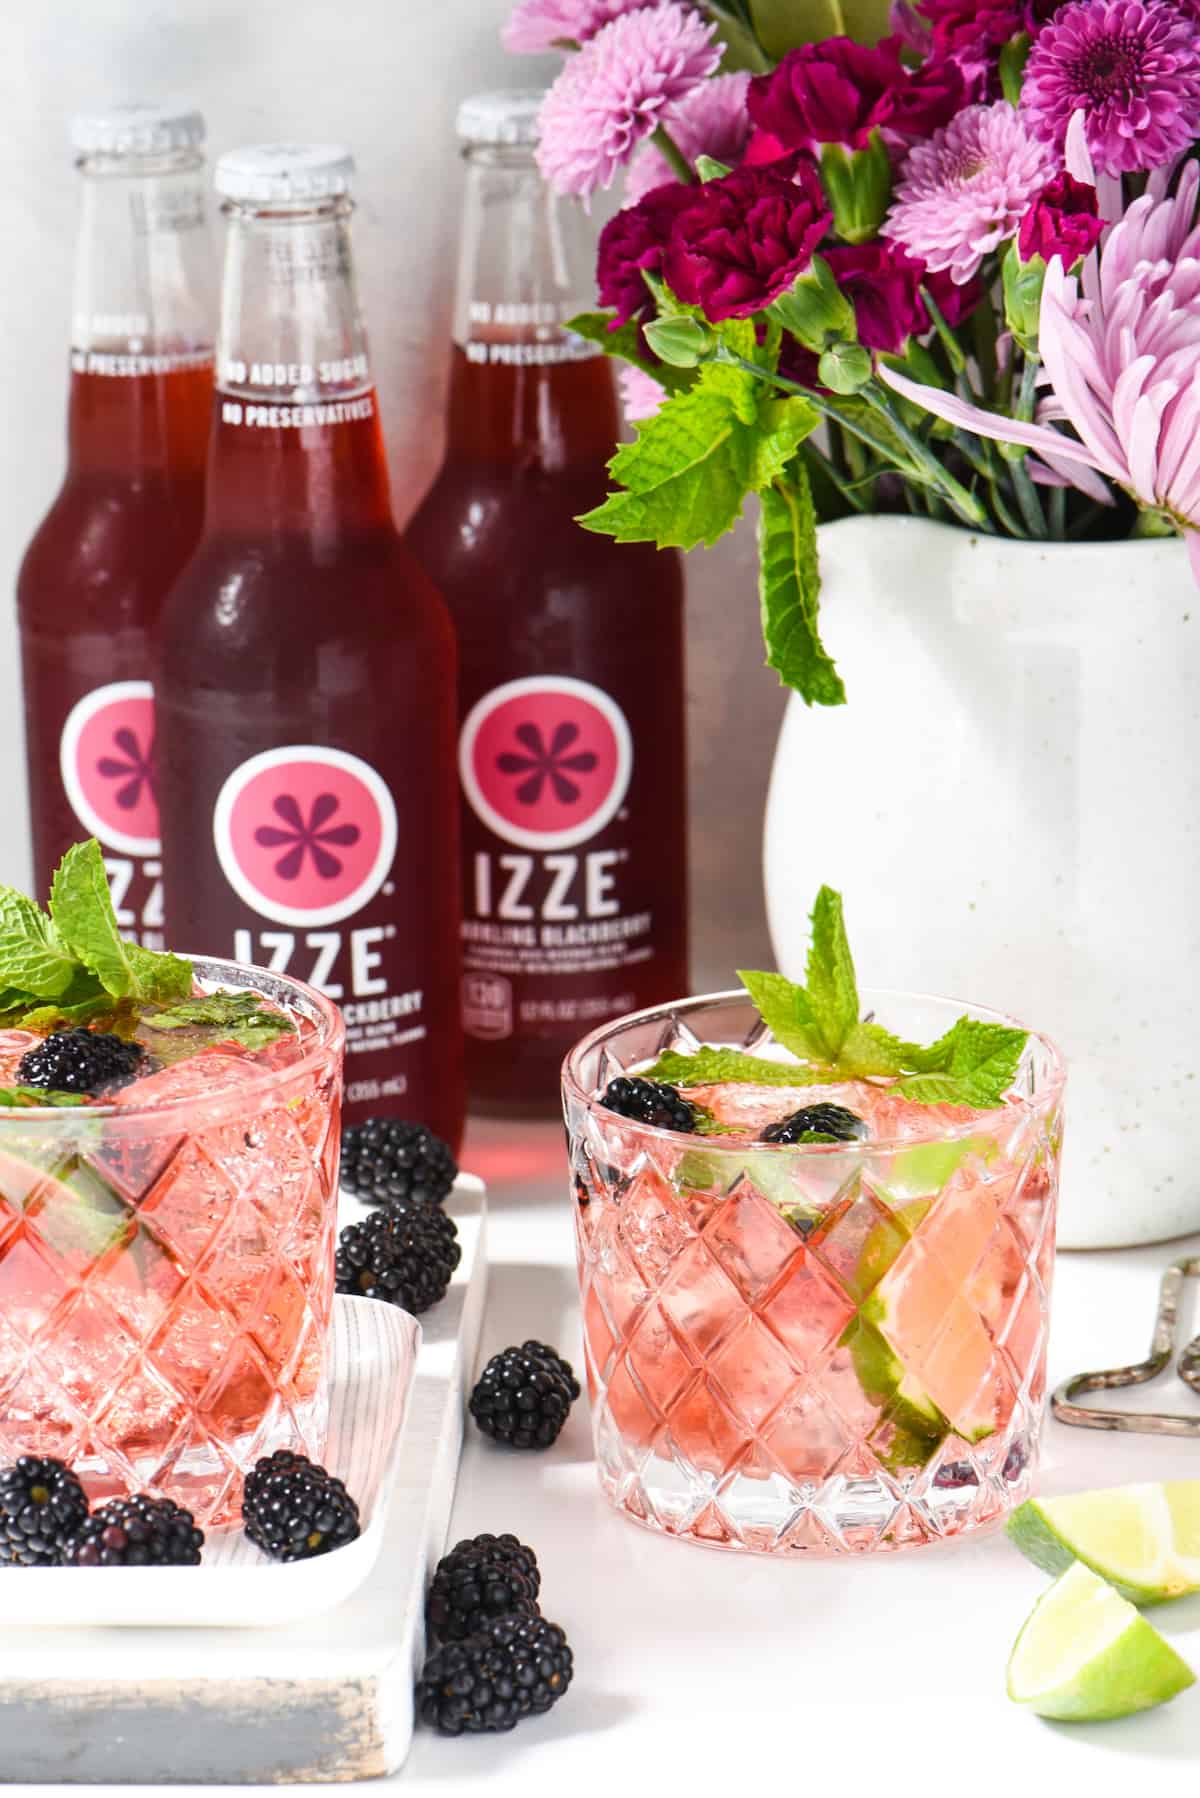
[882,101,1054,286]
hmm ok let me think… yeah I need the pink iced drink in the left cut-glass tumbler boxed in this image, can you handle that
[0,962,342,1525]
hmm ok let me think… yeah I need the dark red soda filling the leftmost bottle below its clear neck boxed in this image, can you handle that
[18,352,212,948]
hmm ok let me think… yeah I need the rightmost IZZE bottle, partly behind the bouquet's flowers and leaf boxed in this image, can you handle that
[408,93,687,1113]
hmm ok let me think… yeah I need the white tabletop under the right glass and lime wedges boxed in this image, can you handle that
[16,1122,1200,1798]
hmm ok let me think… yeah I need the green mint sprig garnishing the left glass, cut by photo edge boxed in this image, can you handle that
[0,838,193,1030]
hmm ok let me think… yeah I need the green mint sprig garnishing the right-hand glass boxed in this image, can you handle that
[648,886,1027,1111]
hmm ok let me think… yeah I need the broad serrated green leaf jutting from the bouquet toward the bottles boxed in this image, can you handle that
[579,363,817,548]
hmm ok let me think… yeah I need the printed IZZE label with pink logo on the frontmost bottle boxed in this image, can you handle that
[212,744,426,1100]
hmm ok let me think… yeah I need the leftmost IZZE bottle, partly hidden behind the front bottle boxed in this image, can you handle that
[18,106,216,949]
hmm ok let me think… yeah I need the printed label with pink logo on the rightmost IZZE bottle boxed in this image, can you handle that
[459,674,653,1041]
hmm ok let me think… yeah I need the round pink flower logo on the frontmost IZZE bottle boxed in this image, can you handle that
[212,744,396,924]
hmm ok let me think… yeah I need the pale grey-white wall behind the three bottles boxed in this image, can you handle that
[0,0,781,987]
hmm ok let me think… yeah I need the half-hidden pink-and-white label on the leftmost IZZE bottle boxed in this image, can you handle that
[59,680,164,949]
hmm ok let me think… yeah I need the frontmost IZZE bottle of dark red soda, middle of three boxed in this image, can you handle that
[157,144,464,1144]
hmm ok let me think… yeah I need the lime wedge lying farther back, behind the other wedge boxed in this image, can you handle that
[1007,1480,1200,1604]
